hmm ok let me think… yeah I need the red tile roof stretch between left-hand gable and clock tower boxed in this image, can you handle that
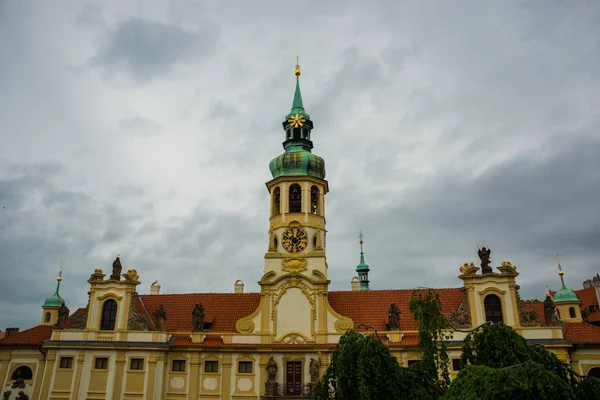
[136,293,260,333]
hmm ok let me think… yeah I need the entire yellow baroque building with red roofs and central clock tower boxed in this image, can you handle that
[0,66,600,400]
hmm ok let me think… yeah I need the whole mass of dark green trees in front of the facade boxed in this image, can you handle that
[315,296,600,400]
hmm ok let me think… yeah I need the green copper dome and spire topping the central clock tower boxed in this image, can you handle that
[269,60,325,179]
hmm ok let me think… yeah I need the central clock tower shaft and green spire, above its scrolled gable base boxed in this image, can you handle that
[264,57,329,279]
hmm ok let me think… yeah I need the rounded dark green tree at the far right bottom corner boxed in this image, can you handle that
[444,324,600,400]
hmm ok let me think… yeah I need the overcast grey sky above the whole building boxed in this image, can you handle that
[0,0,600,330]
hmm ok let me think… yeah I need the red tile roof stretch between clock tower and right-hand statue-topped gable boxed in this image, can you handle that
[329,288,464,331]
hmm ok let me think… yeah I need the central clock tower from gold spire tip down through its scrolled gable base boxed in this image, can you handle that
[236,59,353,346]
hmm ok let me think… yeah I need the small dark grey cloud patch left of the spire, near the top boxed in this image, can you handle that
[90,18,216,82]
